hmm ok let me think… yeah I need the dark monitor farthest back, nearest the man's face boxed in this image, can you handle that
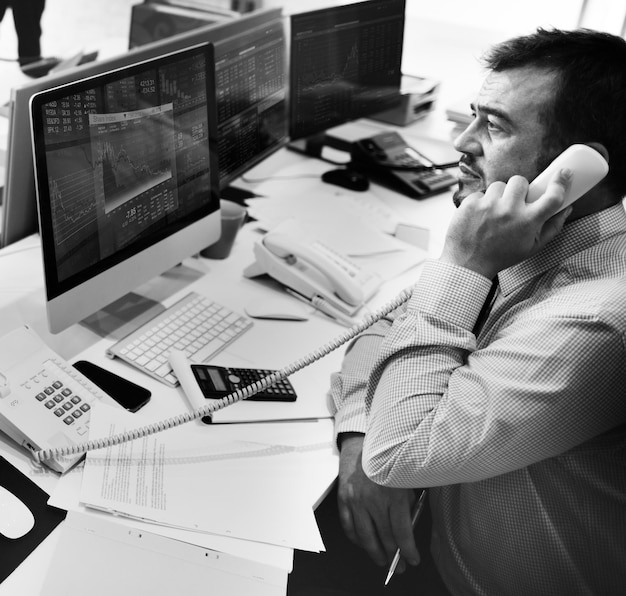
[289,0,405,140]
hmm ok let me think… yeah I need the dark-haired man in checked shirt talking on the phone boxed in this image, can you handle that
[331,30,626,595]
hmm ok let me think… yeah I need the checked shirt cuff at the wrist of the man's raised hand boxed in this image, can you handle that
[407,260,492,329]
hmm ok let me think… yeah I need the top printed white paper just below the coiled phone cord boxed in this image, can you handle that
[80,405,338,552]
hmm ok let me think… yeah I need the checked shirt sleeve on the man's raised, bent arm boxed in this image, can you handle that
[363,263,626,487]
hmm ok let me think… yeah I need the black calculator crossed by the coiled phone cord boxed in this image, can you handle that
[191,364,297,401]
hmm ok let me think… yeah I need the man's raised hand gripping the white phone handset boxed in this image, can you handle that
[441,171,571,279]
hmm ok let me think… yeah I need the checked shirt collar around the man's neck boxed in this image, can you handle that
[498,202,626,296]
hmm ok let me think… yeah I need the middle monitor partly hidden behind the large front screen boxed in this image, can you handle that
[0,9,287,246]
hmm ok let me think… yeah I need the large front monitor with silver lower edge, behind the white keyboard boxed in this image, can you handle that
[31,44,220,333]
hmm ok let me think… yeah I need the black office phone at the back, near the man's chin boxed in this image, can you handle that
[350,131,458,199]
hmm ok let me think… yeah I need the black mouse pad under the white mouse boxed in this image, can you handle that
[0,457,67,582]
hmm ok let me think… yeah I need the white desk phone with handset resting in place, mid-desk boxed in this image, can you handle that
[244,232,382,315]
